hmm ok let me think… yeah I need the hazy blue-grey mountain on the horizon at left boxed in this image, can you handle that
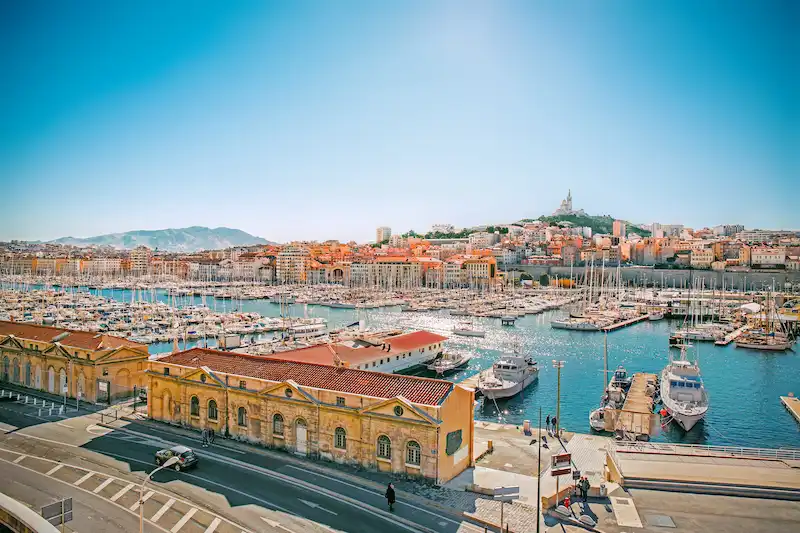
[50,226,274,252]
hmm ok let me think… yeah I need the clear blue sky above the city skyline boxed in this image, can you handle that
[0,0,800,241]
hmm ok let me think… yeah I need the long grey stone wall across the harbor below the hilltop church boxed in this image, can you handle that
[505,265,800,290]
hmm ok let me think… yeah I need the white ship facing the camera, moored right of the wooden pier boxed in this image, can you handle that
[661,345,708,431]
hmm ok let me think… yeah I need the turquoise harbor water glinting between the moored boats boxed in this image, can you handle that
[12,290,800,448]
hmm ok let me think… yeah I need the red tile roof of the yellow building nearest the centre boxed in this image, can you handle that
[158,347,454,405]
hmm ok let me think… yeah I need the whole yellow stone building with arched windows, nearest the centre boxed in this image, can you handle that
[147,348,474,483]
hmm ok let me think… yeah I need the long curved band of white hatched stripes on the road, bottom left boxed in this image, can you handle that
[0,448,252,533]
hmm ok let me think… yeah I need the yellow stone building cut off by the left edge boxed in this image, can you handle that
[0,321,148,403]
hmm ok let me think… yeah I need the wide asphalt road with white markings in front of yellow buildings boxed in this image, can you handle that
[0,390,483,533]
